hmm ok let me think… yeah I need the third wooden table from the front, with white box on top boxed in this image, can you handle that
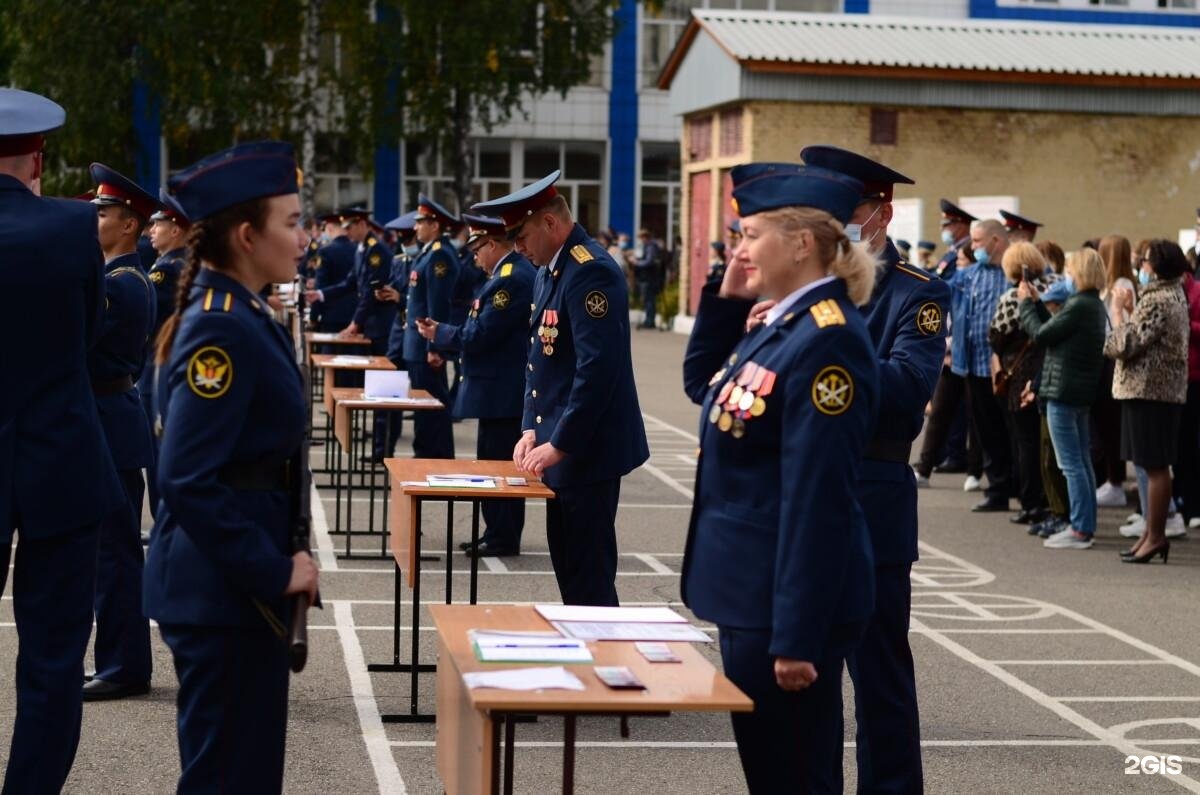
[332,387,445,558]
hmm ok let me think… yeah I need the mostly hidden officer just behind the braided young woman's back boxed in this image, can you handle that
[138,189,192,516]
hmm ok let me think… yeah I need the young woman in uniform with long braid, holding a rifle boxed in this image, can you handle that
[143,142,317,793]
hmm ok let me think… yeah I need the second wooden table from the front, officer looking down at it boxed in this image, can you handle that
[367,459,554,723]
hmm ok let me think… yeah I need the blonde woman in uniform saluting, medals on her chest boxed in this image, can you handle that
[683,163,878,793]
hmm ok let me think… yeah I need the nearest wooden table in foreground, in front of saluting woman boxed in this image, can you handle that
[430,604,754,795]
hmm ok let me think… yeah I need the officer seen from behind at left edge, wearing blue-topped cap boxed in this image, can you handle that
[0,88,122,793]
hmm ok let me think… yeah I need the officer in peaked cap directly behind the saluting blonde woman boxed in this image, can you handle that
[800,147,950,793]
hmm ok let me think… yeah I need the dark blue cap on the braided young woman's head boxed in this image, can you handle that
[167,141,300,222]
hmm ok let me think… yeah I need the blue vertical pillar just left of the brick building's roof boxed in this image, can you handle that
[609,0,638,234]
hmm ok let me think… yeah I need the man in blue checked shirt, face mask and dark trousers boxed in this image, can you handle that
[949,219,1013,513]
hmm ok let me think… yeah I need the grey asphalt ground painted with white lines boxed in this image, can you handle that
[0,331,1200,795]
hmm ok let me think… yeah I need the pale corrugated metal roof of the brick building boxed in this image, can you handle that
[659,10,1200,88]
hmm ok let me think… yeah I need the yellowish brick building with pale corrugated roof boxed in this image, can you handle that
[659,7,1200,321]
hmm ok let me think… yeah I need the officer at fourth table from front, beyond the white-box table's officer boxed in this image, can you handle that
[400,193,458,459]
